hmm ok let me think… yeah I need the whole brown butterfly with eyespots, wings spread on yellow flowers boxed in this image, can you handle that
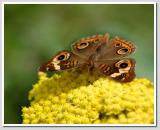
[39,33,136,82]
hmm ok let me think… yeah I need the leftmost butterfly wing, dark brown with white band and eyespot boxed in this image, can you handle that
[39,51,86,71]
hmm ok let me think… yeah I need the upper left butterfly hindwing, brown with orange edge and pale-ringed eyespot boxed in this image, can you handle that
[72,33,109,59]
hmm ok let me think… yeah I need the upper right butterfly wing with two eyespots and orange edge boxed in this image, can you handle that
[95,37,135,61]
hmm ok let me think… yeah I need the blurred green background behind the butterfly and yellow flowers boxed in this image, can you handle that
[4,4,154,124]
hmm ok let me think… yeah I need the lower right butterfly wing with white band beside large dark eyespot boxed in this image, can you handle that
[94,58,135,82]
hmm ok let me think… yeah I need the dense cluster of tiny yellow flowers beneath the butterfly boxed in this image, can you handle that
[22,70,154,124]
